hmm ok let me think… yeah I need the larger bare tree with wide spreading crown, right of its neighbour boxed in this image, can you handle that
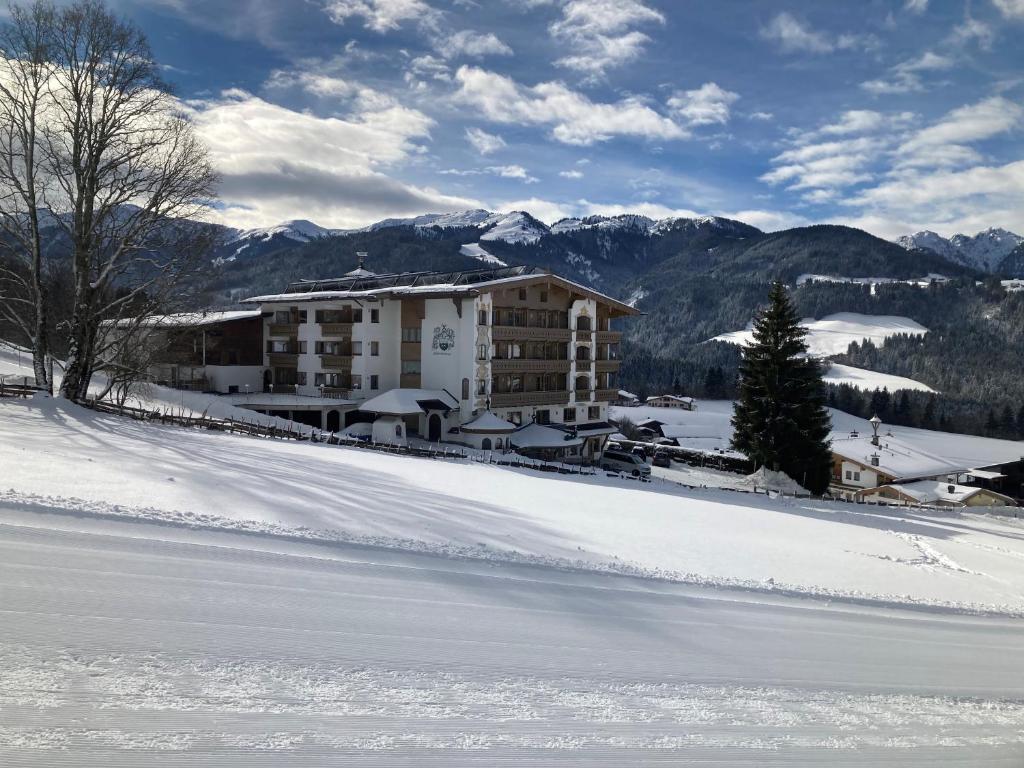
[13,0,216,400]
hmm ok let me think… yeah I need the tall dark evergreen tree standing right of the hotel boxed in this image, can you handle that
[732,283,831,494]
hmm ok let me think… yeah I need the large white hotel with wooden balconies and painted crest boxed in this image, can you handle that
[240,266,638,461]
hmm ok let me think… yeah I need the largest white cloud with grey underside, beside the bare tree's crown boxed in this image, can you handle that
[184,90,479,227]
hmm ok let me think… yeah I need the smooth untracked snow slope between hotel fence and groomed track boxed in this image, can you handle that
[8,401,1024,610]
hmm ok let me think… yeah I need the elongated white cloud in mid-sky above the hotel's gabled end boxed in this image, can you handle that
[455,66,688,145]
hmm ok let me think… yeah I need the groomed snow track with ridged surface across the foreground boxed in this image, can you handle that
[0,511,1024,768]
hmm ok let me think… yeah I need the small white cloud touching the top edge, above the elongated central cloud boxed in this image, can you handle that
[550,0,665,77]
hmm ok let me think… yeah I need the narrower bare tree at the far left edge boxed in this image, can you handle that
[0,2,54,389]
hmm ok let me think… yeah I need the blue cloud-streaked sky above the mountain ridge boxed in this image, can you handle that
[108,0,1024,237]
